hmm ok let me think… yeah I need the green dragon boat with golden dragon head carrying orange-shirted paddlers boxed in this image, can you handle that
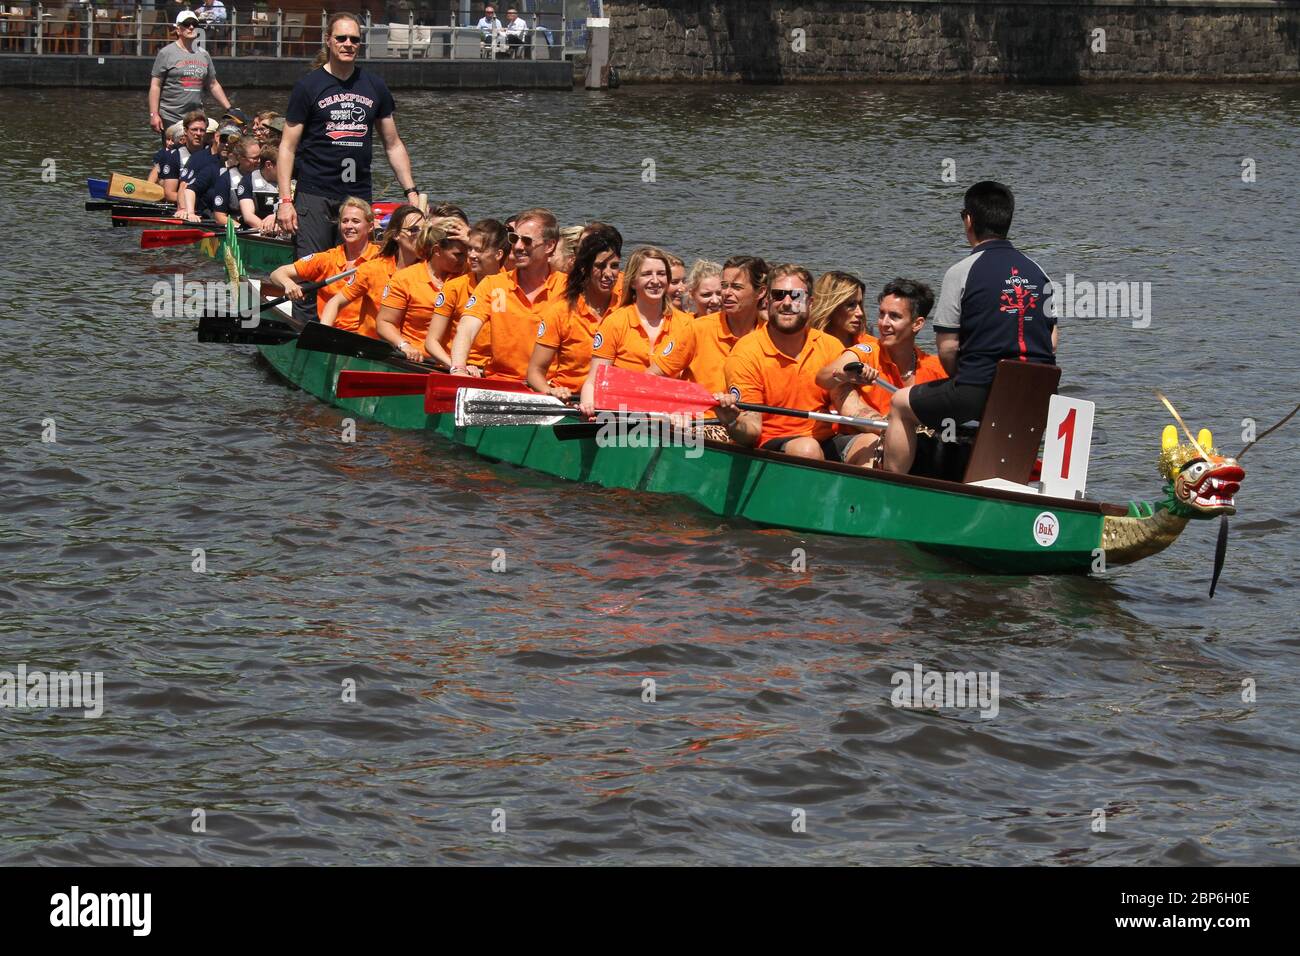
[175,221,1244,576]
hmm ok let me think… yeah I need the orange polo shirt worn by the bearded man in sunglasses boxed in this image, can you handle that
[725,325,844,445]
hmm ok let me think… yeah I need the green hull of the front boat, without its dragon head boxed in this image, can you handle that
[253,335,1104,574]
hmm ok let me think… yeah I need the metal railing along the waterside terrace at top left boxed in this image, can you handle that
[0,4,574,60]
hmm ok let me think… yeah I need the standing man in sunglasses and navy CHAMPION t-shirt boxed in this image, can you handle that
[276,13,419,320]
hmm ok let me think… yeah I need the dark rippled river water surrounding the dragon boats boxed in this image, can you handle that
[0,83,1300,865]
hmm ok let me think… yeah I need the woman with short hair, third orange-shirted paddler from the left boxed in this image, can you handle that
[374,216,467,362]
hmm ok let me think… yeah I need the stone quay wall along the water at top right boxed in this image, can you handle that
[605,0,1300,83]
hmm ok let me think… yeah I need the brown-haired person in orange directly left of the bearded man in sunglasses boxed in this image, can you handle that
[650,256,767,392]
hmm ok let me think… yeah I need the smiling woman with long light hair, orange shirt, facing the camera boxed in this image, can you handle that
[579,246,694,416]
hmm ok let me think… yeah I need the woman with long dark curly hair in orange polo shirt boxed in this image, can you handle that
[528,225,623,402]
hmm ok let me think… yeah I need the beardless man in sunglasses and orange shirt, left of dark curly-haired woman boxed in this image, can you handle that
[451,209,566,381]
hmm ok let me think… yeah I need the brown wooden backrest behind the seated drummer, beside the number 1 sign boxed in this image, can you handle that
[962,359,1061,485]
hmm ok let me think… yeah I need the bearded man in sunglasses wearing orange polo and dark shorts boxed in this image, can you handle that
[716,265,854,462]
